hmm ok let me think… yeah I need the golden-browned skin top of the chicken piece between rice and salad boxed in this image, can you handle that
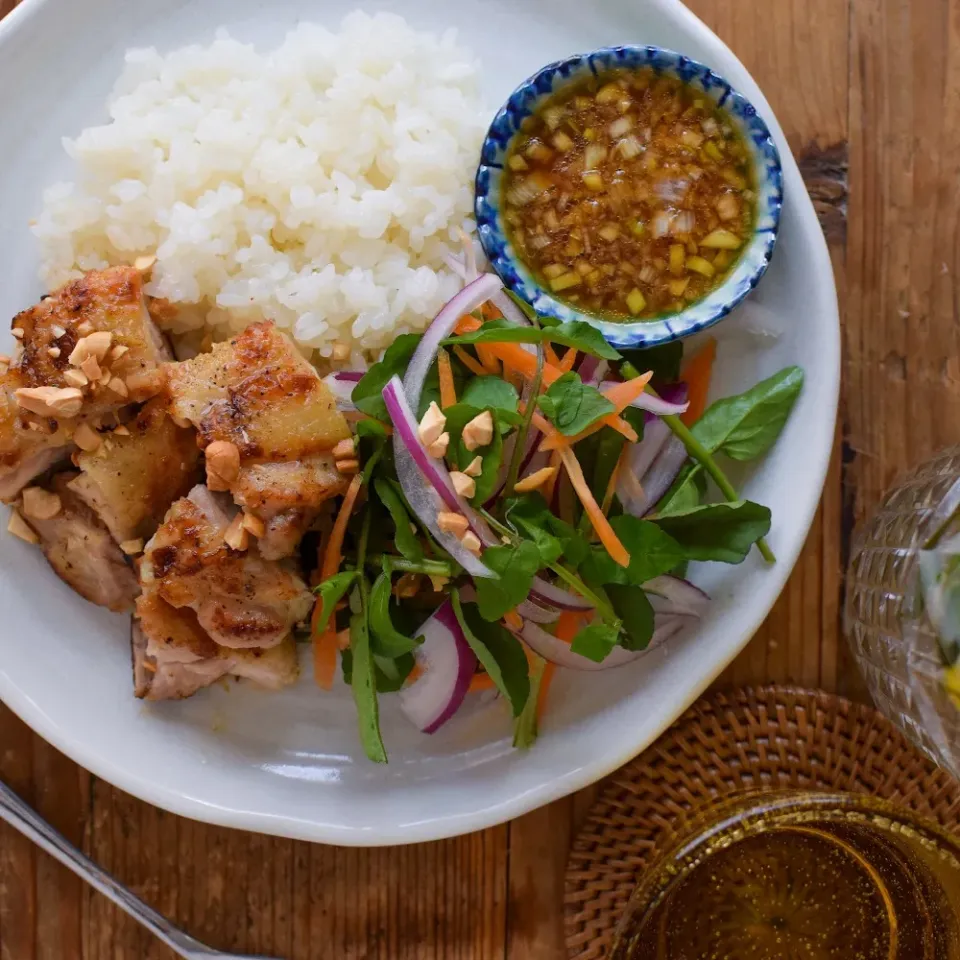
[167,321,350,460]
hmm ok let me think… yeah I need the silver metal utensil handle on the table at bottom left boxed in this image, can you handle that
[0,783,284,960]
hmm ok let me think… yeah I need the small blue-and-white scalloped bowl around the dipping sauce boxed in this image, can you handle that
[475,46,783,349]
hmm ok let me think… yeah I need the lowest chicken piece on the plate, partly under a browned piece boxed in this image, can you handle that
[131,593,299,700]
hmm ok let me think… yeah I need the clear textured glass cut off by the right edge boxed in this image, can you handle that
[844,447,960,777]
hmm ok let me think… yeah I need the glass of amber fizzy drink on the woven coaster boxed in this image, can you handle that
[610,791,960,960]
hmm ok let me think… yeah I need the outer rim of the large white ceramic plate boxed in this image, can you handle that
[0,0,841,847]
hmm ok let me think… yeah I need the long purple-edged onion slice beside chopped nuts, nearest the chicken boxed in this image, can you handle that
[383,376,493,577]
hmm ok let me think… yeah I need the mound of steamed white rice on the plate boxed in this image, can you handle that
[33,12,488,359]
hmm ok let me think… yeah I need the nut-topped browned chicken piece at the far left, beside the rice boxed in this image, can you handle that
[0,267,171,501]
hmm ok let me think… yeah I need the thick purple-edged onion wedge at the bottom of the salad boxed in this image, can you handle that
[399,600,477,733]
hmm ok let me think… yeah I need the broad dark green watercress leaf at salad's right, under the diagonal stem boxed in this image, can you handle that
[651,500,770,563]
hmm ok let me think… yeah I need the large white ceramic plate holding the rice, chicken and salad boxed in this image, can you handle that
[0,0,840,845]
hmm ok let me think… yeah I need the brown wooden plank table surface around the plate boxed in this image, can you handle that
[7,0,960,960]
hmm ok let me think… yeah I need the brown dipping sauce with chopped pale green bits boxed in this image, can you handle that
[503,68,756,321]
